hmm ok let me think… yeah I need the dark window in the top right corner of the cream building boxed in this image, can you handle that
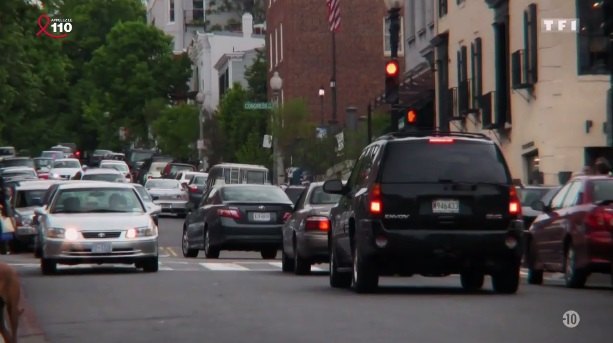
[577,0,613,74]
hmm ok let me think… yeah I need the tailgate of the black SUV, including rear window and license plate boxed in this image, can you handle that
[377,138,513,230]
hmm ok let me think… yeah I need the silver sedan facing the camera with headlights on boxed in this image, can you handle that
[36,181,158,274]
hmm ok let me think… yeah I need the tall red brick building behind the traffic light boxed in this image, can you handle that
[266,0,404,129]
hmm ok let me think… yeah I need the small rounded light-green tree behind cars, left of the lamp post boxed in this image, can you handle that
[152,105,200,160]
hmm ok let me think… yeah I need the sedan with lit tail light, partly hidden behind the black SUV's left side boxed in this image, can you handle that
[281,182,340,275]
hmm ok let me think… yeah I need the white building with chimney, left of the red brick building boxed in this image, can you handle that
[189,13,265,115]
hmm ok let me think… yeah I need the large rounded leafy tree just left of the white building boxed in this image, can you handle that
[83,22,191,148]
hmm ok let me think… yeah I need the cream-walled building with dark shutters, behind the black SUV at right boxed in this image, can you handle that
[432,0,613,184]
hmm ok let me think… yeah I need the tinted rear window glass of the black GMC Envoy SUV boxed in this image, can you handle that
[381,140,511,184]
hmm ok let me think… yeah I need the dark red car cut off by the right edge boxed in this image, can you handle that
[526,175,613,288]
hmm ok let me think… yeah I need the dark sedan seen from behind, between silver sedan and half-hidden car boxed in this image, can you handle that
[182,184,293,259]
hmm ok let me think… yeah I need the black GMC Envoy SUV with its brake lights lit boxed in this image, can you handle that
[324,131,524,293]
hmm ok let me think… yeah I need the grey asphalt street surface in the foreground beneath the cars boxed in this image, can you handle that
[0,218,613,343]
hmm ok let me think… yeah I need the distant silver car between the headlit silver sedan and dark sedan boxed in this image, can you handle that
[145,179,189,216]
